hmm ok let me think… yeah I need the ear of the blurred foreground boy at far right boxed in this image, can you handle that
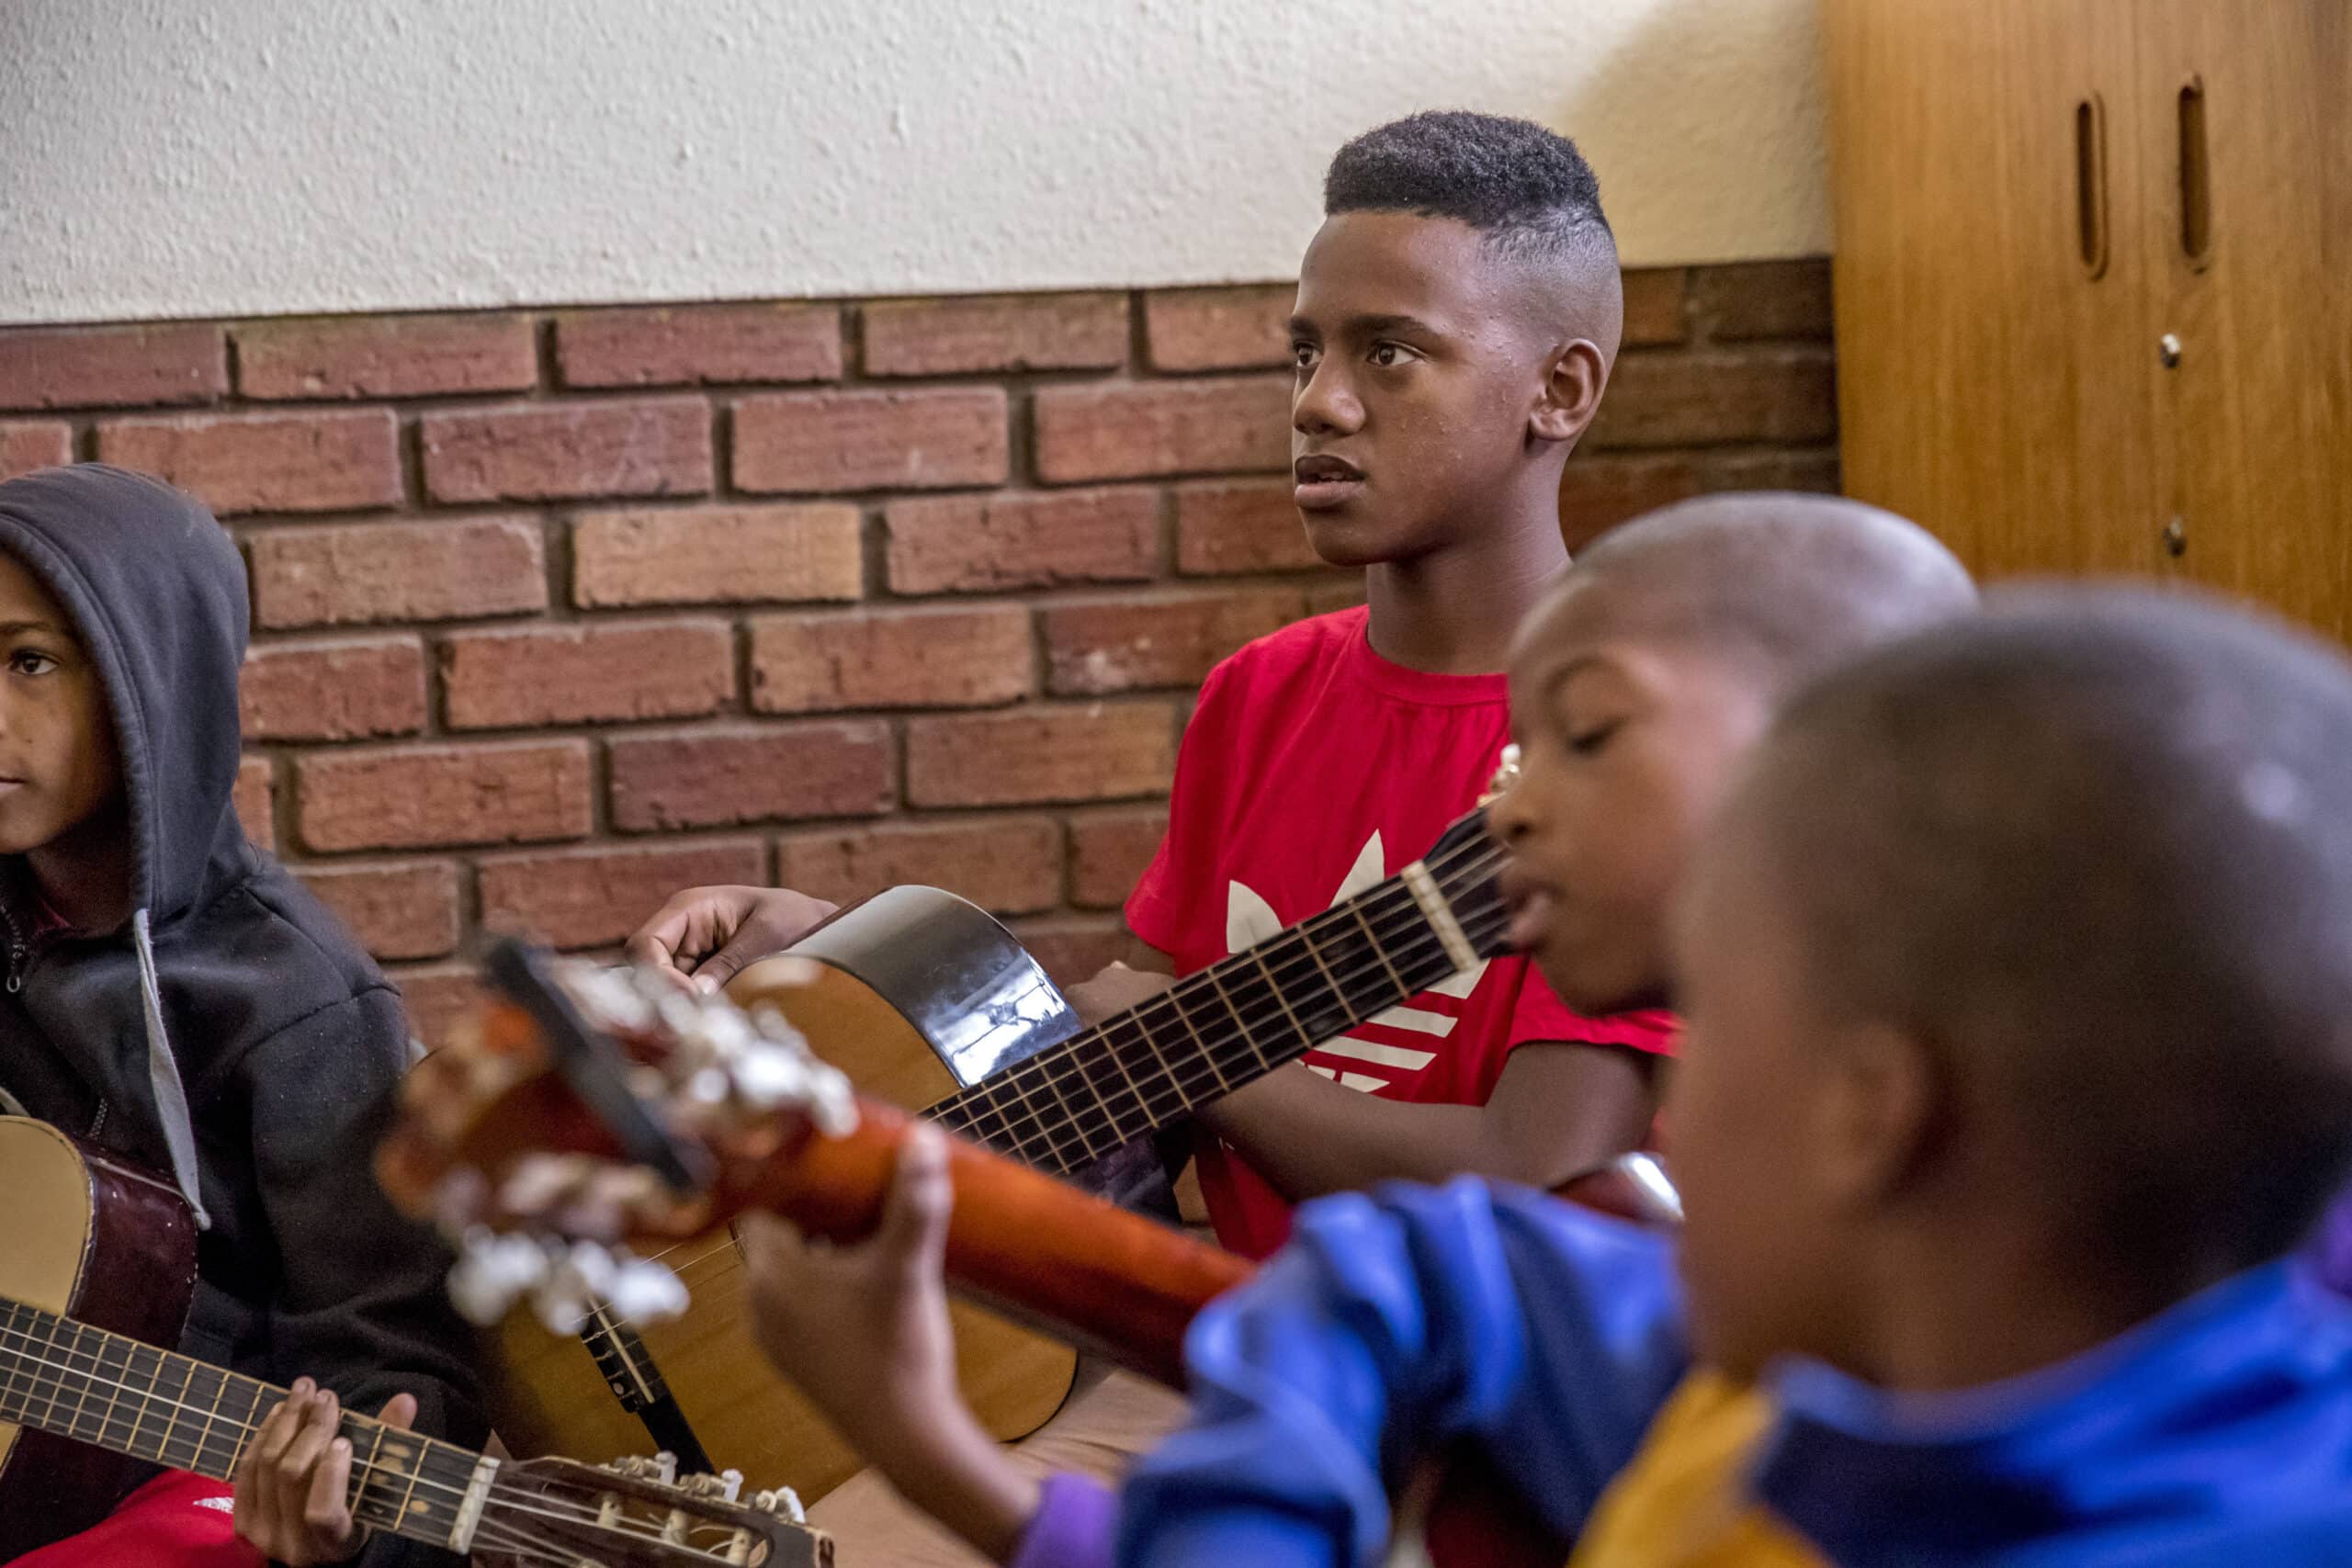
[1811,1022,1950,1211]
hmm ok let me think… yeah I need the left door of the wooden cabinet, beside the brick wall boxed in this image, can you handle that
[1826,0,2162,576]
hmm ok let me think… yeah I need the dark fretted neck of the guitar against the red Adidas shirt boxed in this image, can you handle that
[927,813,1508,1176]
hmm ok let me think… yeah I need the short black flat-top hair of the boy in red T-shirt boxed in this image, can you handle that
[1324,110,1616,256]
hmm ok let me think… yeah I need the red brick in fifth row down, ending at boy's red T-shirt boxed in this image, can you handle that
[906,703,1176,807]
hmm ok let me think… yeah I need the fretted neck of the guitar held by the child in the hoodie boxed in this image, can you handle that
[0,1300,499,1551]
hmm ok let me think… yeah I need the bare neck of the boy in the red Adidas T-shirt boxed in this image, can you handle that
[1364,502,1569,674]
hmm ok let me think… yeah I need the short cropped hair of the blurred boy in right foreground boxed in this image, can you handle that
[1724,588,2352,1267]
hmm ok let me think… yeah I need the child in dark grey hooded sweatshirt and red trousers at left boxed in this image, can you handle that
[0,466,484,1568]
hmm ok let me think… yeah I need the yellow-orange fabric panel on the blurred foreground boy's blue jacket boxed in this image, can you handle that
[1569,1373,1830,1568]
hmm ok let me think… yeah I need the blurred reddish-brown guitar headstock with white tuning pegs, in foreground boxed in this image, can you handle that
[377,942,856,1333]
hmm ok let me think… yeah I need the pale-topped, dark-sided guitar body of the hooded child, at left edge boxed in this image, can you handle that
[0,1117,195,1561]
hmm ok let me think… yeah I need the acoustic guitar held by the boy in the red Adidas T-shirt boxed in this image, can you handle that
[494,789,1510,1497]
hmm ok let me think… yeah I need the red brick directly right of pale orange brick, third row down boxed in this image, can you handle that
[885,489,1159,592]
